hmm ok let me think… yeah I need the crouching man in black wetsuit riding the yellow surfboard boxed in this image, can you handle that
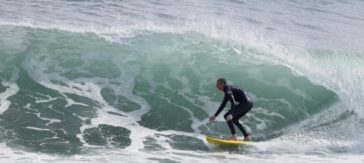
[210,78,253,141]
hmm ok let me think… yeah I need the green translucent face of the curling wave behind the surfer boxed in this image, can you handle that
[0,26,338,154]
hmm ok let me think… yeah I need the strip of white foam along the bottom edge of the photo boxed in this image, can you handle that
[0,141,364,163]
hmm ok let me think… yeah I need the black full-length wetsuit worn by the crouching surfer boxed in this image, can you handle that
[215,85,253,136]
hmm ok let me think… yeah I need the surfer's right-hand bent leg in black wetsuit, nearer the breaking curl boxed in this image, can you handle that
[232,103,253,137]
